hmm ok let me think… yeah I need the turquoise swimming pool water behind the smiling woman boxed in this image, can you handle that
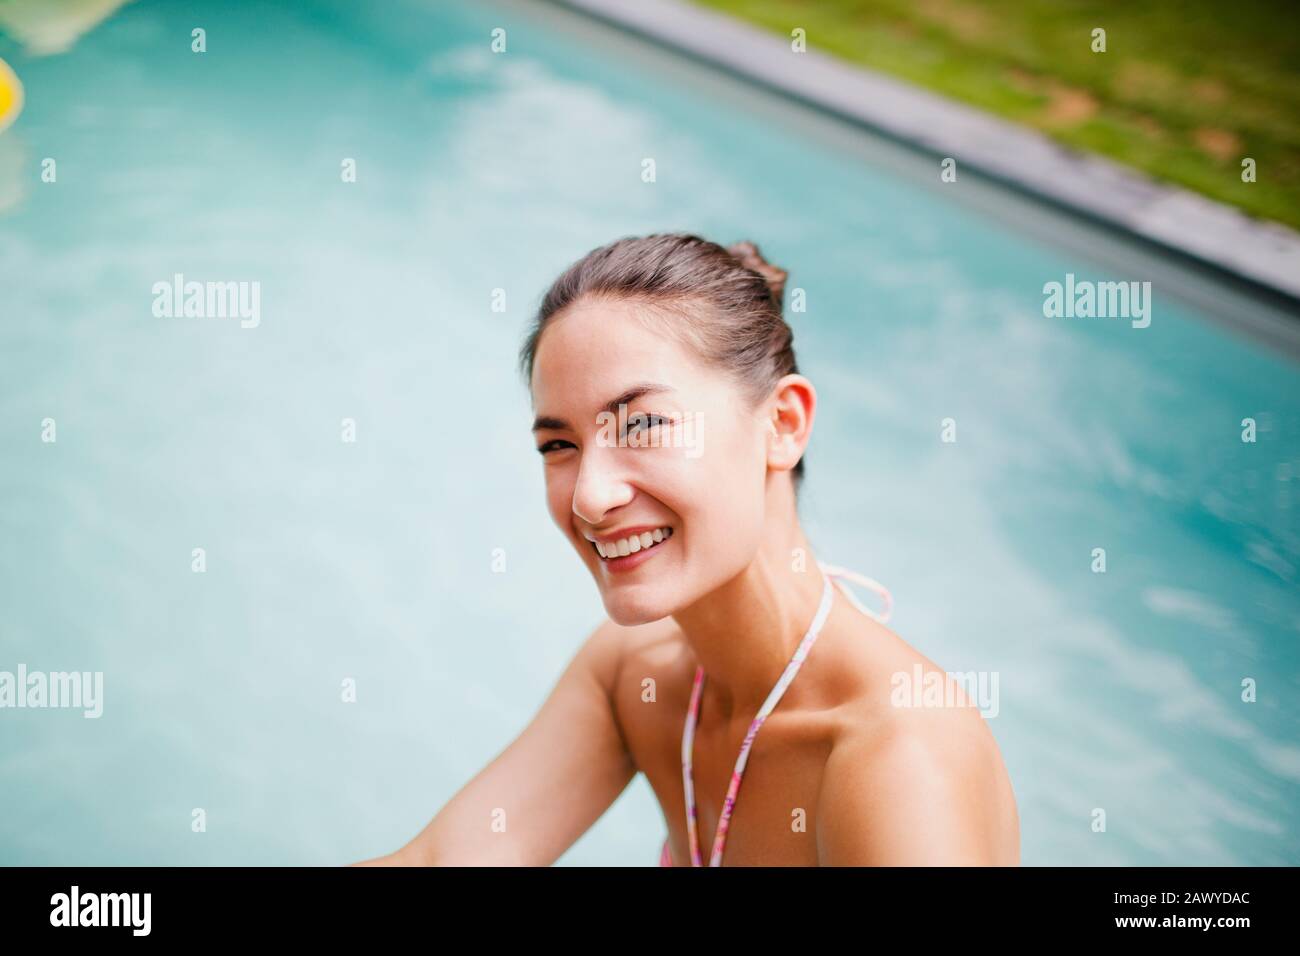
[0,1,1300,865]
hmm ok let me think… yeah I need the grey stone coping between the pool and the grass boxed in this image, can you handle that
[550,0,1300,307]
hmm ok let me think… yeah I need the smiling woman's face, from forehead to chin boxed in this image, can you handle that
[532,300,768,626]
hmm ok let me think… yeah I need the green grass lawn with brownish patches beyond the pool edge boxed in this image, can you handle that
[694,0,1300,228]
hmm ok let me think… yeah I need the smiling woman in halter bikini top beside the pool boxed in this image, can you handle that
[358,234,1019,866]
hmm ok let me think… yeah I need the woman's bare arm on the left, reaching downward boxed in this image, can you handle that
[352,622,636,866]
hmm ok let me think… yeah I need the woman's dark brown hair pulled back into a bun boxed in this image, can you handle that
[519,233,803,489]
